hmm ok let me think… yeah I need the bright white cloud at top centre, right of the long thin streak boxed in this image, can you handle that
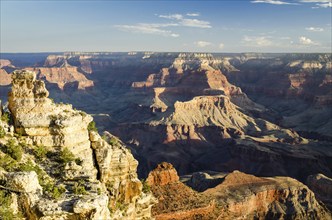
[159,14,212,28]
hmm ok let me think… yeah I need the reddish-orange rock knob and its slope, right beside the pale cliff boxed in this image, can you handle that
[146,162,215,220]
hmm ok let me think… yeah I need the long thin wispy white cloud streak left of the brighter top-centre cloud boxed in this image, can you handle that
[115,24,180,37]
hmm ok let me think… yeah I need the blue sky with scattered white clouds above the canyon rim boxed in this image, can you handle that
[0,0,332,53]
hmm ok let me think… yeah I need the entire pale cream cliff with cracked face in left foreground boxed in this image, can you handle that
[1,70,154,219]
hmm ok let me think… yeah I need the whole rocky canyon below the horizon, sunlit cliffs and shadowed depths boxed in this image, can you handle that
[0,52,332,219]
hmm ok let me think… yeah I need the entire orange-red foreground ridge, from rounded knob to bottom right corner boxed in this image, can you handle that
[148,163,331,219]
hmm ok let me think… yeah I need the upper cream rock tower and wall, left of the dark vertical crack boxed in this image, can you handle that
[9,70,97,179]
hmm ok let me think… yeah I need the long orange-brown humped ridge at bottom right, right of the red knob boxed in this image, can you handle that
[204,171,331,219]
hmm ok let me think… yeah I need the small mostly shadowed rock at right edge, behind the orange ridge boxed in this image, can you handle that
[306,174,332,210]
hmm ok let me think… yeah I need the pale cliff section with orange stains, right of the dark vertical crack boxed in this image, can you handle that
[90,131,155,219]
